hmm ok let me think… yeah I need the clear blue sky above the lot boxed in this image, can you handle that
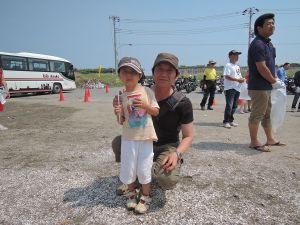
[0,0,300,74]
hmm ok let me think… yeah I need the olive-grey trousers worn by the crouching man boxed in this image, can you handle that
[112,136,183,190]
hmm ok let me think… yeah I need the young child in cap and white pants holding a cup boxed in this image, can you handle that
[115,57,159,213]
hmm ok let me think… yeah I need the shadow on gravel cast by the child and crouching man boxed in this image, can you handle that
[63,176,166,212]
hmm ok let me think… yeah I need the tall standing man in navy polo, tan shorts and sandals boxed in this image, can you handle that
[248,13,284,152]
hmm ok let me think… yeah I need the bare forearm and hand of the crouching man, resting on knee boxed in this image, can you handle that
[162,123,194,171]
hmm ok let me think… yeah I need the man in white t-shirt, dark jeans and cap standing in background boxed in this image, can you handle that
[223,50,244,128]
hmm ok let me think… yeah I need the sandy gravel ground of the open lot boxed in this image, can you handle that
[0,89,300,225]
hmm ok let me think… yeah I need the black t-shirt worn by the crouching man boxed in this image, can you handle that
[152,92,194,146]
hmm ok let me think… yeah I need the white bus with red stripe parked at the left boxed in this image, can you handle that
[0,52,76,94]
